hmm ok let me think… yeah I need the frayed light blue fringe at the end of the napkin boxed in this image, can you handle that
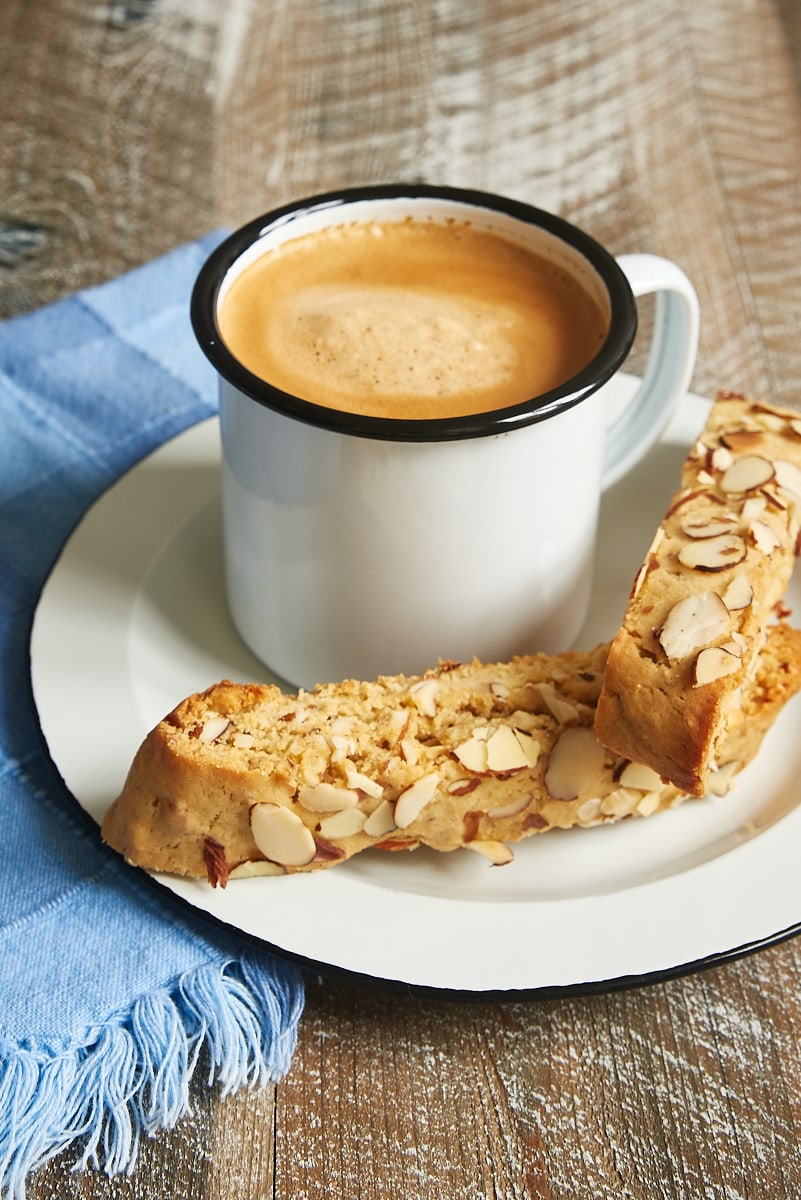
[0,955,303,1200]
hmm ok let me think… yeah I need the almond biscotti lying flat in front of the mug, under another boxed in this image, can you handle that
[103,626,801,886]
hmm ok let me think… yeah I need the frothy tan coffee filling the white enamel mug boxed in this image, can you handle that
[218,220,608,420]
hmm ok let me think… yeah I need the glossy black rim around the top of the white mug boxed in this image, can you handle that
[189,177,637,442]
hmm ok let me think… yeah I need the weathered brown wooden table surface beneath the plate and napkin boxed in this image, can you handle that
[6,0,801,1200]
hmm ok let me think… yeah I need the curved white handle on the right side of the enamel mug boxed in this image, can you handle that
[602,254,699,488]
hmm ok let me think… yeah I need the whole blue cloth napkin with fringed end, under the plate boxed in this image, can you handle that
[0,235,303,1200]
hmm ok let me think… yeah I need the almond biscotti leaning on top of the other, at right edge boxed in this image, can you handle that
[595,394,801,796]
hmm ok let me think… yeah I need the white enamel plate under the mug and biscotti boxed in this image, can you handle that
[31,377,801,995]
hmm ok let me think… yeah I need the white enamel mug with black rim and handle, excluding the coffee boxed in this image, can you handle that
[192,185,698,686]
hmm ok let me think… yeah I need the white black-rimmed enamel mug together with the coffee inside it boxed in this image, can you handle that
[192,185,698,688]
